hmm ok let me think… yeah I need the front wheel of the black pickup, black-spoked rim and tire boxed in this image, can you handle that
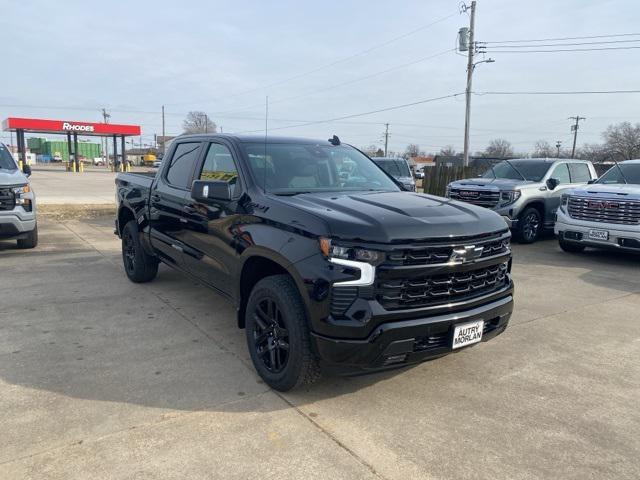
[245,275,321,392]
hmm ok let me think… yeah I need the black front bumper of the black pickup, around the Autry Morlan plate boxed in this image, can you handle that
[312,286,513,374]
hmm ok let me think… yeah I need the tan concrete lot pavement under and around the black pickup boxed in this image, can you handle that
[0,220,640,480]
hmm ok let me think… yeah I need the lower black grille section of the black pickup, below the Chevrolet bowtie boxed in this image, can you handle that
[376,262,509,310]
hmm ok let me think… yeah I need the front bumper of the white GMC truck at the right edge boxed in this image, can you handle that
[554,210,640,252]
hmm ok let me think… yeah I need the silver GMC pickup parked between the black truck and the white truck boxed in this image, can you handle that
[446,158,597,243]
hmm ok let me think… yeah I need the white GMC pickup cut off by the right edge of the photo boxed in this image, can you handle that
[555,160,640,253]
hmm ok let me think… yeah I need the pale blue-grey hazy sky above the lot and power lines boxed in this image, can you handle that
[0,0,640,152]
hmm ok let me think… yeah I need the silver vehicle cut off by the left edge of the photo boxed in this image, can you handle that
[0,143,38,248]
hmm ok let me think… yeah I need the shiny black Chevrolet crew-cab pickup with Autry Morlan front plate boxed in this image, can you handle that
[116,135,513,390]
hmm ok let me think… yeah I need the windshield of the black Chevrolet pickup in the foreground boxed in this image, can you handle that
[242,143,399,195]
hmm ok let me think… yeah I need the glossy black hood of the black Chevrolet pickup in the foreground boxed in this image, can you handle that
[277,192,507,243]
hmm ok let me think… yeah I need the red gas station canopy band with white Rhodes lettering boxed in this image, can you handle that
[2,117,140,136]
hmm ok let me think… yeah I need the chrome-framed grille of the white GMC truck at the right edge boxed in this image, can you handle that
[568,196,640,225]
